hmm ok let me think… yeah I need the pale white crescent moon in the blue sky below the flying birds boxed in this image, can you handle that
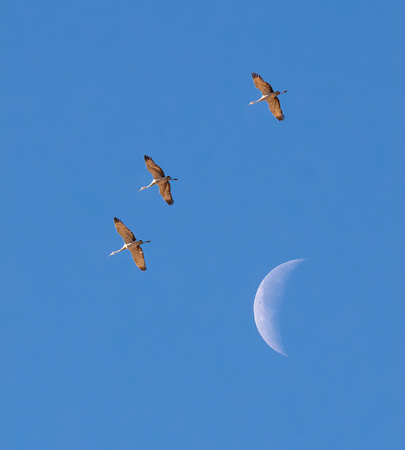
[253,259,305,356]
